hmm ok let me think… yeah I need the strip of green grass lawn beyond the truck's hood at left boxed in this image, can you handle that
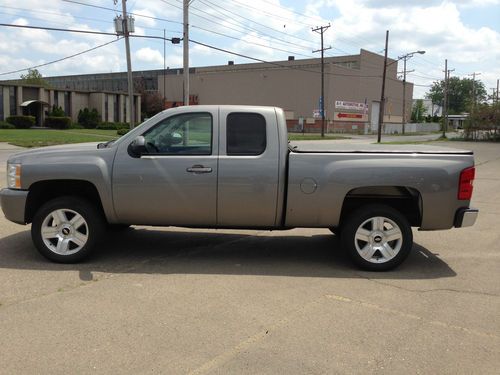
[0,129,119,147]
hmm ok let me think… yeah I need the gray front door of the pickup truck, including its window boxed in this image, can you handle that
[113,109,219,226]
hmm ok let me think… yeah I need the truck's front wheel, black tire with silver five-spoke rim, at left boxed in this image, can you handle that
[31,197,105,263]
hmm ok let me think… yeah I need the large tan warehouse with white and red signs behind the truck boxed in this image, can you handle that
[158,50,413,132]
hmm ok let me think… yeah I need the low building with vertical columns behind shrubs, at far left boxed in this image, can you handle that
[0,81,141,126]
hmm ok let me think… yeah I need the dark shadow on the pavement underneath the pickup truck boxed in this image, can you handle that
[0,227,456,280]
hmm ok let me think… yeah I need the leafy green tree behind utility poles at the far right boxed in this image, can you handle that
[425,77,486,114]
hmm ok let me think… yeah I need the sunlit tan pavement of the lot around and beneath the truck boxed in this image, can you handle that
[0,142,500,374]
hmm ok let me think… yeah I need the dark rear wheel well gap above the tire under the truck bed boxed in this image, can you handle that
[340,186,422,227]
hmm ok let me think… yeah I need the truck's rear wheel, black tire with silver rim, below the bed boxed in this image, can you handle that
[341,205,413,271]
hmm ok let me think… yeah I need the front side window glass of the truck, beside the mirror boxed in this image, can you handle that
[143,113,213,155]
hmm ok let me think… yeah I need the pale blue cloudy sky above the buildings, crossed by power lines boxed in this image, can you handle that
[0,0,500,97]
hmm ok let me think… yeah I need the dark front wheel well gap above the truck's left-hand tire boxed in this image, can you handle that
[24,180,104,223]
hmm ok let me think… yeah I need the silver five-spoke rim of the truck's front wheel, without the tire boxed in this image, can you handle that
[40,208,89,255]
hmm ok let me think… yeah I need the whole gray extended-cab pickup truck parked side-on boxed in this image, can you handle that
[0,106,478,271]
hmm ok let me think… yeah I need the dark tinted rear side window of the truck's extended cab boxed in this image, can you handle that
[226,113,266,155]
